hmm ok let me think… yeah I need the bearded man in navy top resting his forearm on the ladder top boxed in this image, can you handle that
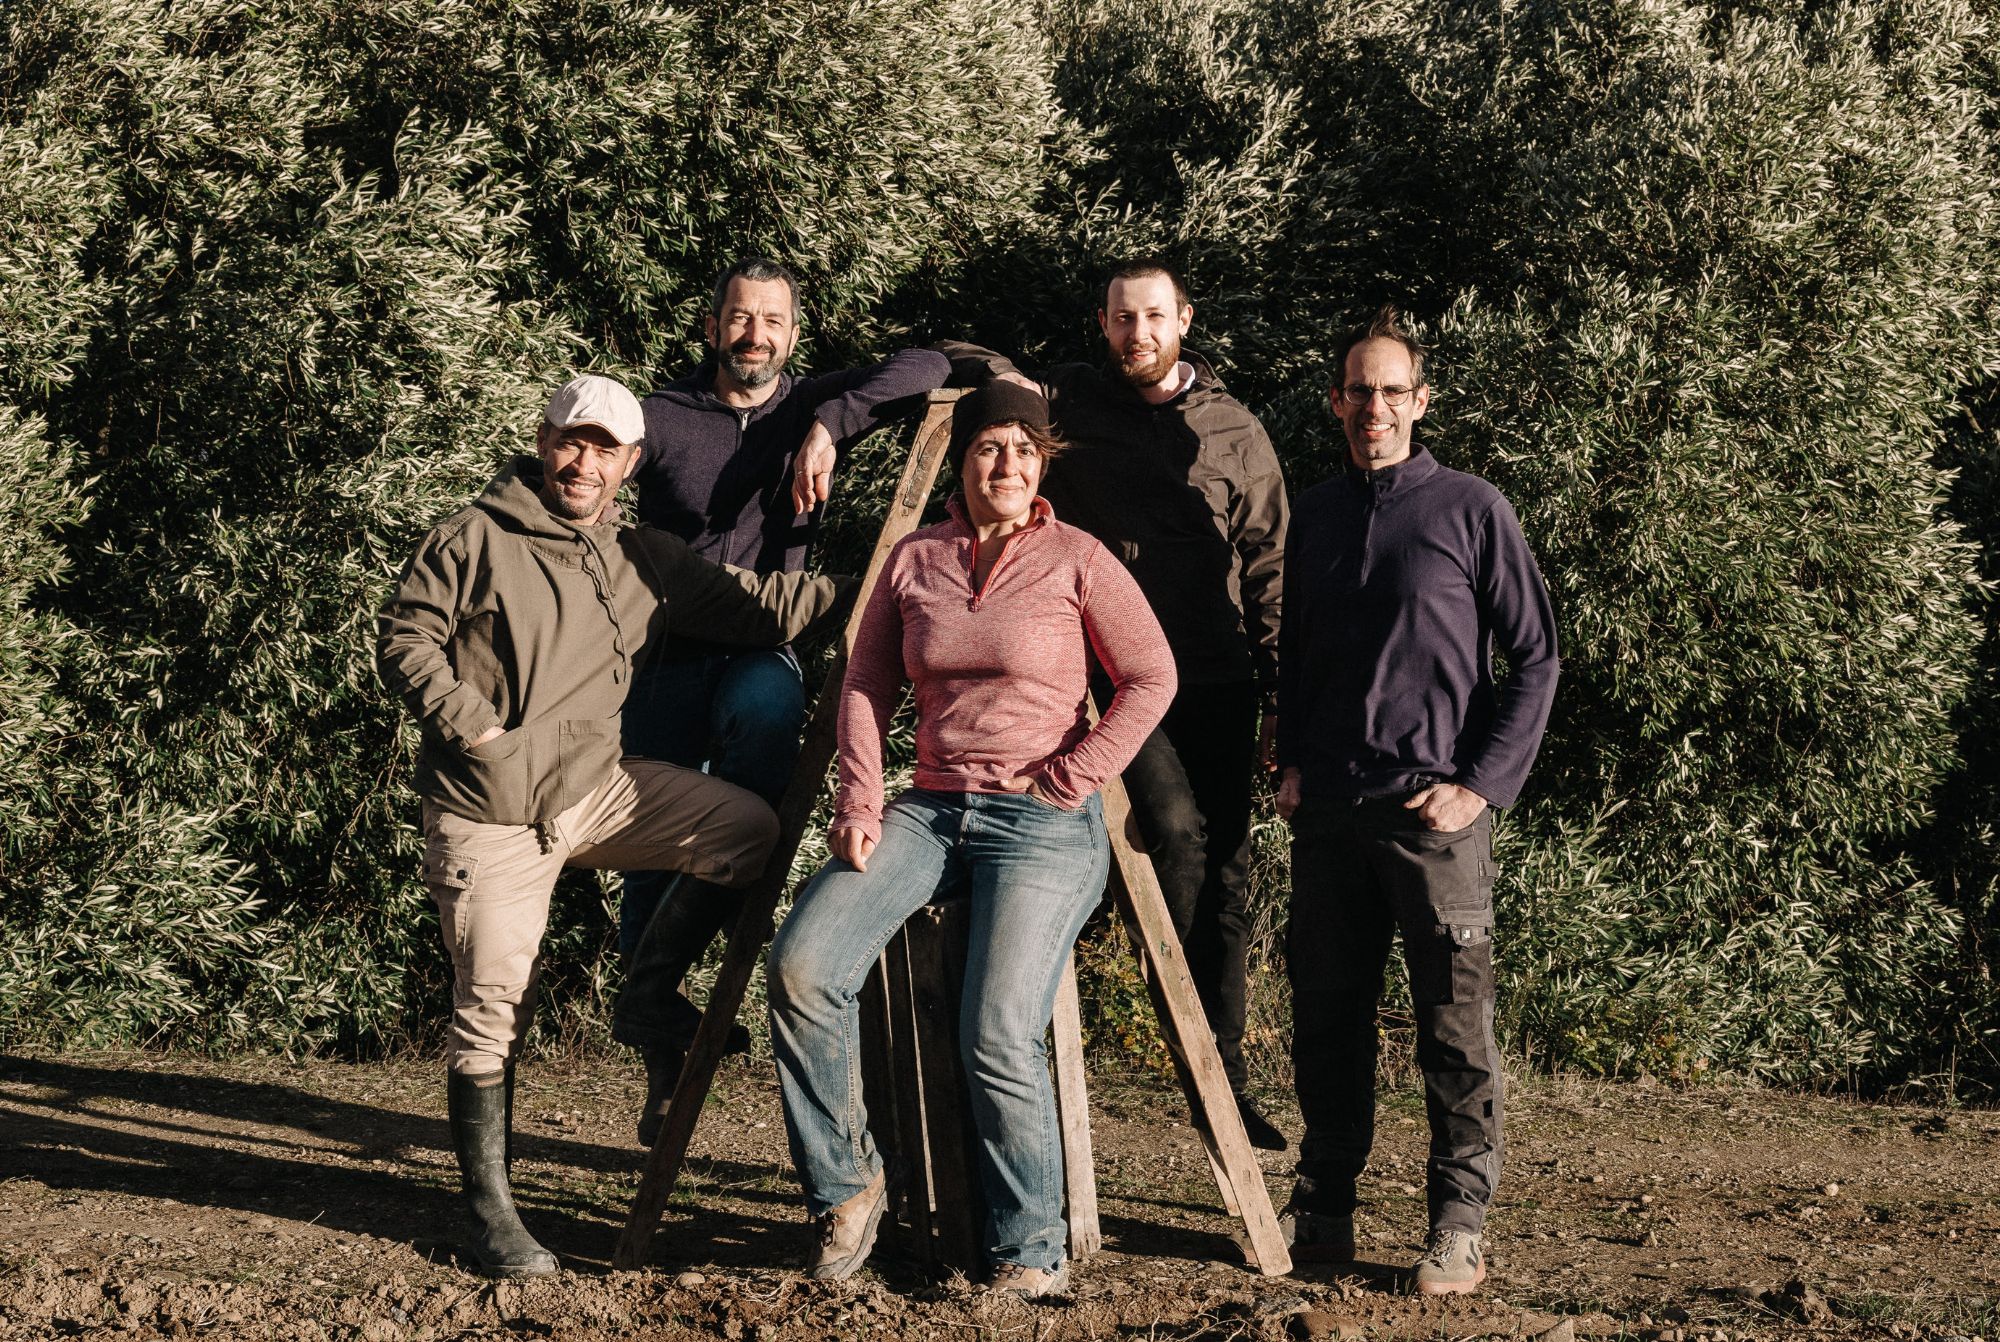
[612,256,950,1146]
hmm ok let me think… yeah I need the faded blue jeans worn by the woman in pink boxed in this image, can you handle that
[766,788,1110,1270]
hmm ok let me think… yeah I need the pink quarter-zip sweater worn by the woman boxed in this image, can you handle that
[834,498,1174,840]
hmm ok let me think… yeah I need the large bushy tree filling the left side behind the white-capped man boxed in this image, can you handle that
[0,0,1048,1048]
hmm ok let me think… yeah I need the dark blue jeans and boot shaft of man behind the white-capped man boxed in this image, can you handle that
[612,648,806,1048]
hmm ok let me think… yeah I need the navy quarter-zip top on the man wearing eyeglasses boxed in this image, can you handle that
[1278,446,1556,806]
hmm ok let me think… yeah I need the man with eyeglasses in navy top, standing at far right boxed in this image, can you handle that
[1278,308,1556,1294]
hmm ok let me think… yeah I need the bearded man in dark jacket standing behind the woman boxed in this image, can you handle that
[938,258,1286,1150]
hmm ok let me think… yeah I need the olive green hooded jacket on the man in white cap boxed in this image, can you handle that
[376,456,854,824]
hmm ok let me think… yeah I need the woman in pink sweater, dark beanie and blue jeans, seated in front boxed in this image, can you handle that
[768,382,1174,1296]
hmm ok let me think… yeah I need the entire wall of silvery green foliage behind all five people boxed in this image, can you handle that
[0,0,2000,1078]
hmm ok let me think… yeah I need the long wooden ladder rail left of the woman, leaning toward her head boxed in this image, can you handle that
[612,390,964,1270]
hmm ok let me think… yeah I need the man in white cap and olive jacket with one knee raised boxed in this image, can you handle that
[376,376,850,1276]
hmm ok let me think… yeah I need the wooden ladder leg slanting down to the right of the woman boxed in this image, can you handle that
[1102,778,1292,1276]
